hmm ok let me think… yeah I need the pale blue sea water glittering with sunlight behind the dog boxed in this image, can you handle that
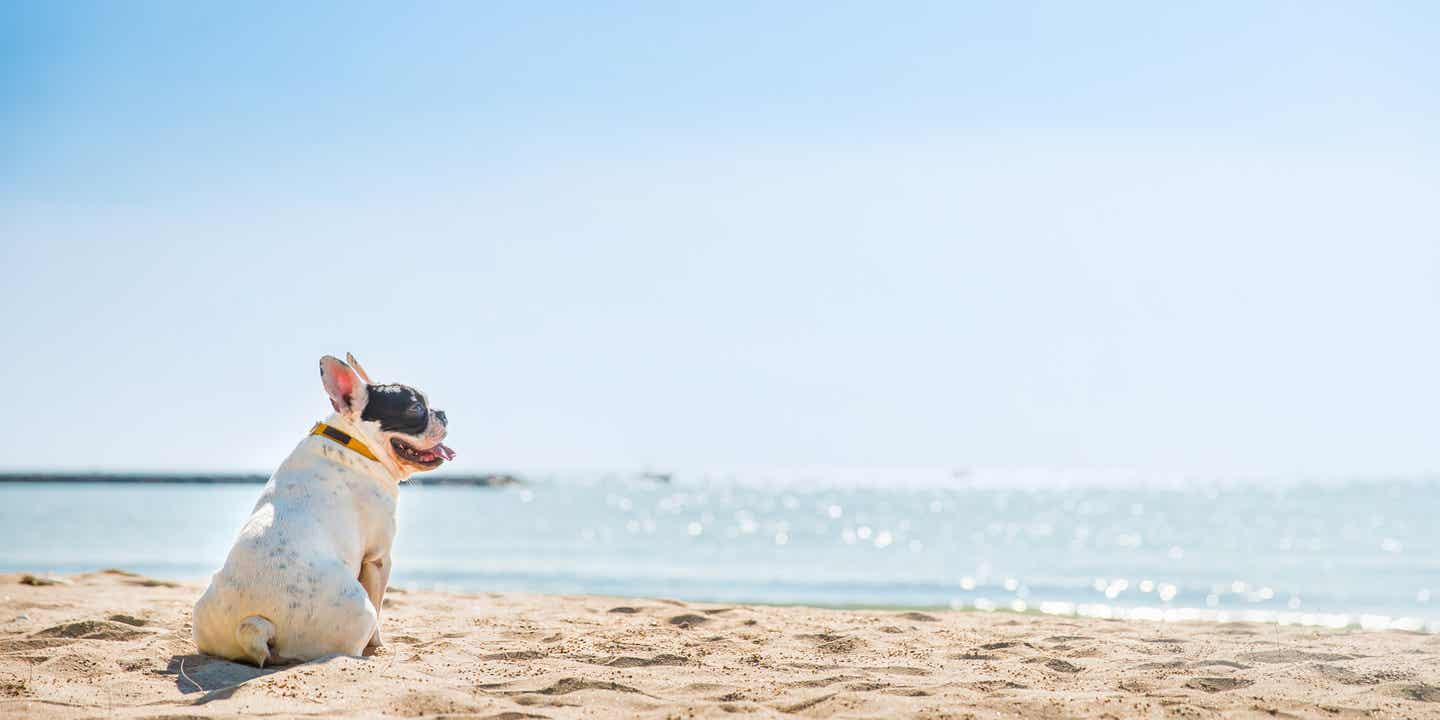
[0,475,1440,631]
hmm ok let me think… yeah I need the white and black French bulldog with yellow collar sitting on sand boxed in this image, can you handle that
[194,356,455,667]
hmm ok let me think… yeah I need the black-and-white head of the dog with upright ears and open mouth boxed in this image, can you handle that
[320,354,455,475]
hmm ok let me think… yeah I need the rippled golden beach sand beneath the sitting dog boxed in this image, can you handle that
[0,570,1440,720]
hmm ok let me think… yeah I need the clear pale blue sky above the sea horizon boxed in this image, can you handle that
[0,1,1440,472]
